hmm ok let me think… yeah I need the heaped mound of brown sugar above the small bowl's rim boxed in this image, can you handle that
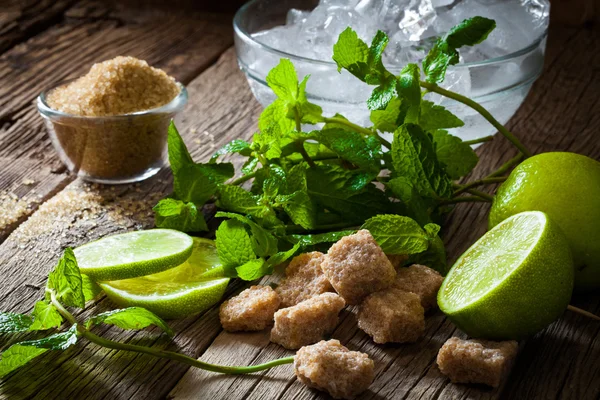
[47,57,179,117]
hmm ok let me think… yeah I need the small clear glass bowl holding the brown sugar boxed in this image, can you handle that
[37,80,188,184]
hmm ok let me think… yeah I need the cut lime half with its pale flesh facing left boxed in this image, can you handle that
[438,211,573,340]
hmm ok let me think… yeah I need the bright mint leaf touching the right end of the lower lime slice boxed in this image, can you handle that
[216,219,256,276]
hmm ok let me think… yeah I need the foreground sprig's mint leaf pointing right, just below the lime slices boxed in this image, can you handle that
[85,307,174,336]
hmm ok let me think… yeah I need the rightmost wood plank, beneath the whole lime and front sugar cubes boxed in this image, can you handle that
[169,24,600,400]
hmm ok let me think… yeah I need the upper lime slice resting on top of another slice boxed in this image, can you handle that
[74,229,193,281]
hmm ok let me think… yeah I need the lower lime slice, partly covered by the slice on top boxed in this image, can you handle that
[100,238,229,319]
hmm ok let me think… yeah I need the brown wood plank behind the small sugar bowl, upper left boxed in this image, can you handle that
[0,1,232,241]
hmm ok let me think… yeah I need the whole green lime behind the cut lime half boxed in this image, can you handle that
[489,152,600,290]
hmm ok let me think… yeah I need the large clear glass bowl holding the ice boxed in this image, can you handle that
[234,0,547,140]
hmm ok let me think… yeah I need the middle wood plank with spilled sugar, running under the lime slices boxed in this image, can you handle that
[0,50,260,399]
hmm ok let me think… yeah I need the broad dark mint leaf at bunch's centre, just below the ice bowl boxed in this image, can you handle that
[313,128,381,171]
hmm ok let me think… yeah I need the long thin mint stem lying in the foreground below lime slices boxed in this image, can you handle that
[50,290,294,375]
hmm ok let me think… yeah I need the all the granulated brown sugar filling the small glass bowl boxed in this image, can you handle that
[42,57,183,181]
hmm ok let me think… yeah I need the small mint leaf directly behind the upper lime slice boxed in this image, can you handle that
[152,198,208,232]
